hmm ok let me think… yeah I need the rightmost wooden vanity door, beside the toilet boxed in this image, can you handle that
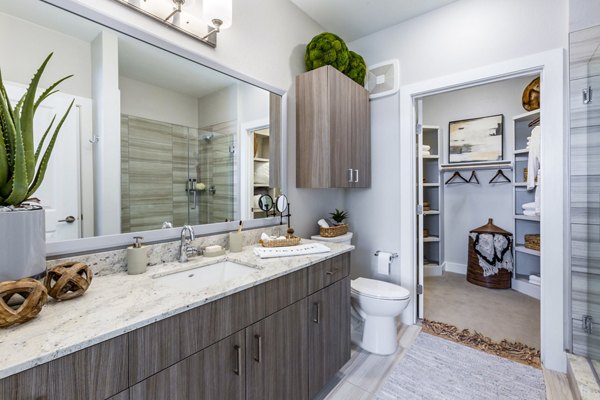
[308,278,350,398]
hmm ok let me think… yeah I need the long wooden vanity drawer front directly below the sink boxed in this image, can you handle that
[128,285,265,386]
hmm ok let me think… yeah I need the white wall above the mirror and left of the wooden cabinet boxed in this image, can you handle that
[49,0,344,236]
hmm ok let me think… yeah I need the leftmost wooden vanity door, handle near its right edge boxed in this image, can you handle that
[129,331,245,400]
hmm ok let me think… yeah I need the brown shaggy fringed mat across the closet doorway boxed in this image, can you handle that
[423,319,542,368]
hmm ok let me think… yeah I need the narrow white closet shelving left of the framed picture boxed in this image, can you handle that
[417,125,443,276]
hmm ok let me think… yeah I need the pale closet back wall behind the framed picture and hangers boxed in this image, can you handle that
[423,77,533,272]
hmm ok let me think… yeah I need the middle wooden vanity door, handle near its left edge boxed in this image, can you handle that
[246,299,308,400]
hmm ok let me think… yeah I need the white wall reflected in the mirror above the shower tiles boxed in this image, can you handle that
[119,76,198,128]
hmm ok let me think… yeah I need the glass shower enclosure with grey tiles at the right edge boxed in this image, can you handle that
[568,26,600,359]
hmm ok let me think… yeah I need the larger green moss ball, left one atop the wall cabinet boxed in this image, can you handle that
[304,32,350,72]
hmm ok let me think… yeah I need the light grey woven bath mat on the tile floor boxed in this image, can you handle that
[376,332,546,400]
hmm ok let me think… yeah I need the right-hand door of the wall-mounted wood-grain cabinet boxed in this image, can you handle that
[350,83,371,188]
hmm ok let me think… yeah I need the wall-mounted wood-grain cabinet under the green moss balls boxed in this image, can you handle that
[296,66,371,188]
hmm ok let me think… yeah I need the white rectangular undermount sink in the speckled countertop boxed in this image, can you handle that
[154,261,257,290]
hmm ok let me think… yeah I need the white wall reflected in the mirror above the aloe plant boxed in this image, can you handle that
[0,13,92,98]
